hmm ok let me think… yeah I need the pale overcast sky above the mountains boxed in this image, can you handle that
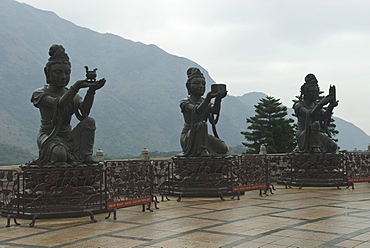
[18,0,370,137]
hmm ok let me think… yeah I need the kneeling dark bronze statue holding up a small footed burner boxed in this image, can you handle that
[31,45,106,167]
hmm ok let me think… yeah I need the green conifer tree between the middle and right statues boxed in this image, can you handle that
[241,96,295,153]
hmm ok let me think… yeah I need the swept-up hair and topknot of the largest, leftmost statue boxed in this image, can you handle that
[44,44,71,84]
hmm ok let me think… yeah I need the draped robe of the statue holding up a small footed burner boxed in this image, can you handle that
[31,85,95,164]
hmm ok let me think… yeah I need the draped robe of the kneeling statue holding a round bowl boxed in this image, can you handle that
[180,98,228,157]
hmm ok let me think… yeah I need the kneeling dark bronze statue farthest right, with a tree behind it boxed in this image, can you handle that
[293,74,338,153]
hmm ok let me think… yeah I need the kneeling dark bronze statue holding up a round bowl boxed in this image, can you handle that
[179,67,228,157]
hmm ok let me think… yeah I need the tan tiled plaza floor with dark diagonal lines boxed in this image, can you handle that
[0,183,370,248]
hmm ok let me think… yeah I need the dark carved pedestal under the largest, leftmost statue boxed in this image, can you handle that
[9,163,106,226]
